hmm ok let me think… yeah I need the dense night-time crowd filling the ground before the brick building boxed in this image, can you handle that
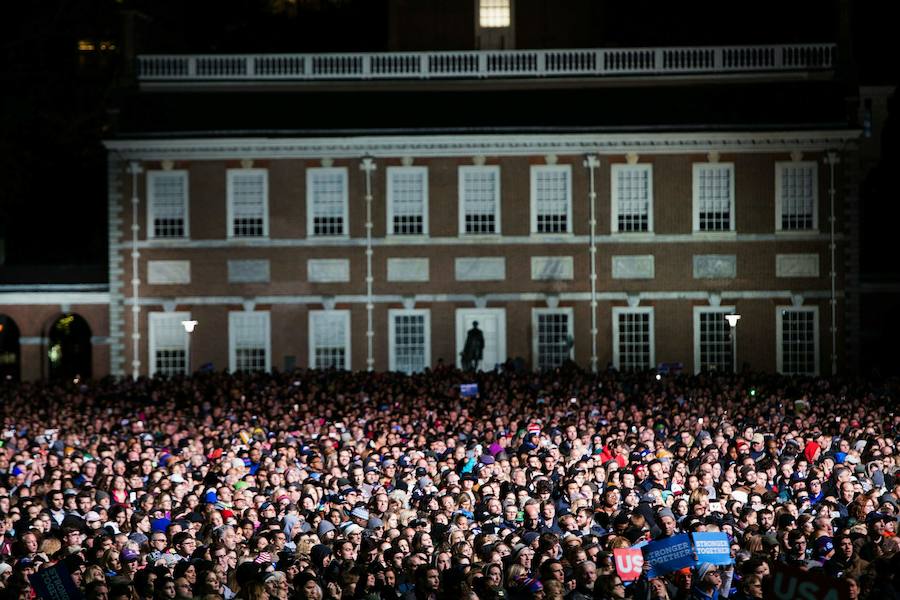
[0,367,900,600]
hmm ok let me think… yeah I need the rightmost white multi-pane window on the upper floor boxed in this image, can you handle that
[775,161,819,231]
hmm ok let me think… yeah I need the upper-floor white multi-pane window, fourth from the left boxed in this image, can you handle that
[387,167,428,235]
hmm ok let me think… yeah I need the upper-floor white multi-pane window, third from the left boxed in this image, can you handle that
[306,167,348,237]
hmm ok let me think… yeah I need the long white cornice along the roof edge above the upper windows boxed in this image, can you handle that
[104,129,860,160]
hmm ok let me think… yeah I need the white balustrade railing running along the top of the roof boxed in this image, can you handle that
[137,44,836,82]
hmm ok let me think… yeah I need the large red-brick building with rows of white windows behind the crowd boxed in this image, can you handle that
[3,3,872,376]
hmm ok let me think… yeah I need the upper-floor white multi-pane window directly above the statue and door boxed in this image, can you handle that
[459,166,500,235]
